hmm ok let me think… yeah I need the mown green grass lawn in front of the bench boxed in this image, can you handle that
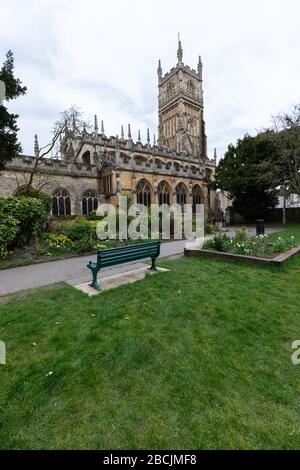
[0,226,300,449]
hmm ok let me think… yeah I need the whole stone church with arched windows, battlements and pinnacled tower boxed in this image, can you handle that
[0,39,220,220]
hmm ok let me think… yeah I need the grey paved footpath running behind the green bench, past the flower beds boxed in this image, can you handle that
[0,227,280,296]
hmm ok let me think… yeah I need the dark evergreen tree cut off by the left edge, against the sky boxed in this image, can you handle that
[0,51,26,170]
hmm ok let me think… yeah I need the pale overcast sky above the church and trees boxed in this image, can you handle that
[0,0,300,160]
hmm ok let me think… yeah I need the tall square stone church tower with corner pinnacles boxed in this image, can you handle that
[157,37,207,160]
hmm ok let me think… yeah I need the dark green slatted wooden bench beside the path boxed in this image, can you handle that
[87,240,160,290]
